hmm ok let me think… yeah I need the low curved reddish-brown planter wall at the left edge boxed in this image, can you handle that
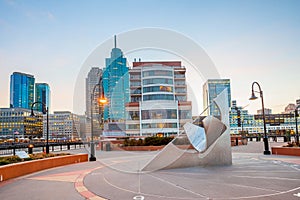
[0,154,88,182]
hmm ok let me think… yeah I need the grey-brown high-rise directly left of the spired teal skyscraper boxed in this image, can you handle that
[85,67,102,138]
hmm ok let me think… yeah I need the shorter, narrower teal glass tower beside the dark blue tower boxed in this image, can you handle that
[35,83,51,112]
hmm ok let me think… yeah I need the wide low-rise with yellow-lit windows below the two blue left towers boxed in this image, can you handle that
[0,108,43,138]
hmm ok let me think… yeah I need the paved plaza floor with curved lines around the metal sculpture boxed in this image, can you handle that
[0,142,300,200]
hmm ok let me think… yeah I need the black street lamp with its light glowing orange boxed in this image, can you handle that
[89,77,107,161]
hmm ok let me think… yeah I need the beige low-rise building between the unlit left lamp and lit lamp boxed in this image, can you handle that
[43,111,80,140]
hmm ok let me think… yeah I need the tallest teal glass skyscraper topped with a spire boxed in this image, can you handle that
[103,36,129,122]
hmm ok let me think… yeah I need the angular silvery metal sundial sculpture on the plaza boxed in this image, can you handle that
[142,90,232,171]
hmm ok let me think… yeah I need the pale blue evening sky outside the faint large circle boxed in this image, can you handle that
[0,0,300,114]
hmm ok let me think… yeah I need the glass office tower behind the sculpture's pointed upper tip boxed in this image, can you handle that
[203,79,231,116]
